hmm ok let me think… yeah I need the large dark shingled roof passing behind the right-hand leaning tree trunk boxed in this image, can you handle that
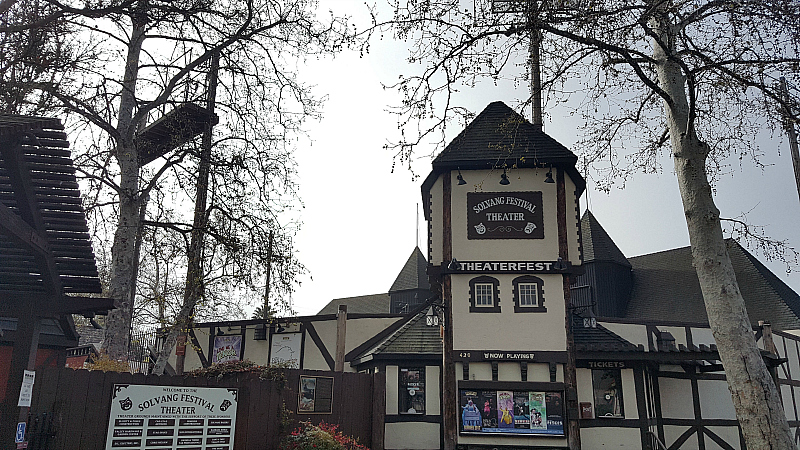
[625,239,800,330]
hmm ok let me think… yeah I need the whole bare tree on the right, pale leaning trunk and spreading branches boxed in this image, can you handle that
[372,0,800,448]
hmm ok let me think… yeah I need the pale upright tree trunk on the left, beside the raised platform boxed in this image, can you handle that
[103,19,145,360]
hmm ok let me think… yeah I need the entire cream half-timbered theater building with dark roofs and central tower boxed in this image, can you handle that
[186,102,800,450]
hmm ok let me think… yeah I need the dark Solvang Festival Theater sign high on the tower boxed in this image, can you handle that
[467,191,544,239]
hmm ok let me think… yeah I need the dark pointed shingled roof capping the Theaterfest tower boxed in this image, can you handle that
[424,102,586,195]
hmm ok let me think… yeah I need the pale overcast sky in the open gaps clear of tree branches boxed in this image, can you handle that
[282,0,800,315]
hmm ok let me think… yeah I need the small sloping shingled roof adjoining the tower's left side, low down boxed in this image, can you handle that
[354,308,442,360]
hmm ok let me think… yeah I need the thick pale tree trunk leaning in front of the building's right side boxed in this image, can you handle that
[654,12,795,449]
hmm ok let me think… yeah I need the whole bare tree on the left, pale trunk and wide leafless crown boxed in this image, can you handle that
[3,0,346,359]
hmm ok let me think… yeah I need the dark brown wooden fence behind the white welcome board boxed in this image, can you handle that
[28,368,385,450]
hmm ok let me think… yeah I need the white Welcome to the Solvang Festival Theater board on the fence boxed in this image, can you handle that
[106,384,238,450]
